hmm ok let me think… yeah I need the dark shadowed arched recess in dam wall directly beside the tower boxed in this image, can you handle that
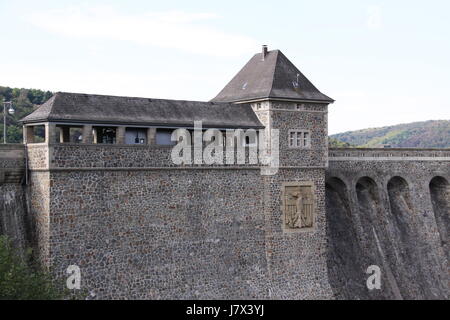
[325,177,368,299]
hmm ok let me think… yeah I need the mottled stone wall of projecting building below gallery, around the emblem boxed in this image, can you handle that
[28,144,332,299]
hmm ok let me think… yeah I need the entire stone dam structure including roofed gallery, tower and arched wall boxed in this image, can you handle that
[0,47,450,299]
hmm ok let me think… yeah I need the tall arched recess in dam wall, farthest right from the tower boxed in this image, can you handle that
[429,176,450,264]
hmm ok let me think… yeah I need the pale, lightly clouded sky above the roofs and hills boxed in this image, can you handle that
[0,0,450,134]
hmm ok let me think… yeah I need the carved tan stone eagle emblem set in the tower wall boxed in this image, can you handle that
[282,182,314,231]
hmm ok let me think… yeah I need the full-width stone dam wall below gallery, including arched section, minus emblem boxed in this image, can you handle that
[0,144,450,299]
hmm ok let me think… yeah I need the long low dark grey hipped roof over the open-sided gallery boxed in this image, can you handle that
[21,92,263,128]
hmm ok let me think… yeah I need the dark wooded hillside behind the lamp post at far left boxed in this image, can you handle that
[0,86,53,143]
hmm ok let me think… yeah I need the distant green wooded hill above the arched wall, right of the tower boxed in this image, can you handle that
[330,120,450,148]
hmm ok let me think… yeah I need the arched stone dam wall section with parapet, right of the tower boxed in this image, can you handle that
[326,149,450,299]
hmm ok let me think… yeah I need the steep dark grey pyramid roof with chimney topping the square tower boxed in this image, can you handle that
[211,50,334,103]
